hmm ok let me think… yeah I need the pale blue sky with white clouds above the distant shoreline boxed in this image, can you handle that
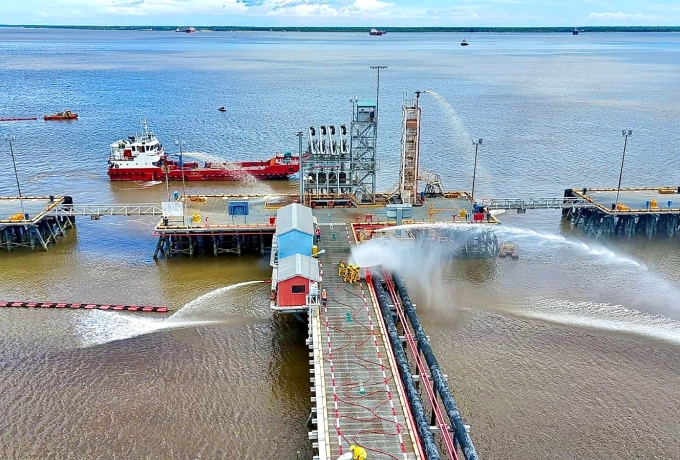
[0,0,680,27]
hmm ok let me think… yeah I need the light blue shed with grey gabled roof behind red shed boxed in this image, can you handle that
[276,203,314,260]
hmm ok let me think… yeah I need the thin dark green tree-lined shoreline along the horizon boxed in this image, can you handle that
[0,24,680,33]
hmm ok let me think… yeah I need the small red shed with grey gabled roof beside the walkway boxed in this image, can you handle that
[276,254,321,308]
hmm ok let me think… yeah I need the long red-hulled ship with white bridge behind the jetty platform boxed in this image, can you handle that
[108,120,300,181]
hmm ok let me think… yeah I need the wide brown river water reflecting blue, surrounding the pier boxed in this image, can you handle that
[0,30,680,460]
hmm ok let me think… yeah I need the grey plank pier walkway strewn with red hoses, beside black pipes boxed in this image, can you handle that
[310,223,423,460]
